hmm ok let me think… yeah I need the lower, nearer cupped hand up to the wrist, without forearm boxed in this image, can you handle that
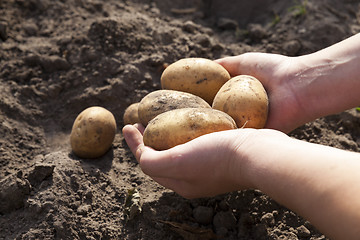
[123,124,288,198]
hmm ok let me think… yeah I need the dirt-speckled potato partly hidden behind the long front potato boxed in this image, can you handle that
[138,90,211,126]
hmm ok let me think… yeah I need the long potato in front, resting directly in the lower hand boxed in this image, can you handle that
[143,108,236,150]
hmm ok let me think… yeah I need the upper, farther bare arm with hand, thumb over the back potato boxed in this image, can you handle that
[217,34,360,133]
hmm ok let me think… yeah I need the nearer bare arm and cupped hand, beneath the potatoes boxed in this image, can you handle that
[123,125,360,239]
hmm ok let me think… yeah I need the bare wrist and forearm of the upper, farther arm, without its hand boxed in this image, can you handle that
[293,35,360,121]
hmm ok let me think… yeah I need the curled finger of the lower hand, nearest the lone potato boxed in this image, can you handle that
[122,125,144,161]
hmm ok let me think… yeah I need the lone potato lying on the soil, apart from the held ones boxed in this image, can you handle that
[70,106,116,158]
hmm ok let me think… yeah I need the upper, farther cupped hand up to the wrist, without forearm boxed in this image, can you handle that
[216,53,307,133]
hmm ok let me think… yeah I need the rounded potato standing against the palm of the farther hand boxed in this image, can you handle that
[212,75,269,128]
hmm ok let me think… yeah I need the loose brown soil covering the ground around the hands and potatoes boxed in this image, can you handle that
[0,0,360,240]
